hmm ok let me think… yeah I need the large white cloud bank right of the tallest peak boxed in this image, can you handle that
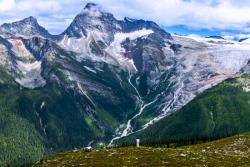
[92,0,250,29]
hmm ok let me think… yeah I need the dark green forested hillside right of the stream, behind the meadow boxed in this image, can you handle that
[118,74,250,143]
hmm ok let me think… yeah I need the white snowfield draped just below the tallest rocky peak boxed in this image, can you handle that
[58,28,154,72]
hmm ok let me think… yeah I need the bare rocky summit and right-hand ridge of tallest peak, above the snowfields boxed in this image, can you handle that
[61,3,171,39]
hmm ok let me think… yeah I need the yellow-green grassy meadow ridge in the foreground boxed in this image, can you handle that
[33,133,250,167]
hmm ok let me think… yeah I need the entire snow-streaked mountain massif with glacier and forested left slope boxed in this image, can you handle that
[0,3,250,166]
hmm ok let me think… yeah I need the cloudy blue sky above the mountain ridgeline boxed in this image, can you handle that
[0,0,250,36]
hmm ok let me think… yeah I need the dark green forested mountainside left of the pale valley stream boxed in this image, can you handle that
[0,60,135,167]
